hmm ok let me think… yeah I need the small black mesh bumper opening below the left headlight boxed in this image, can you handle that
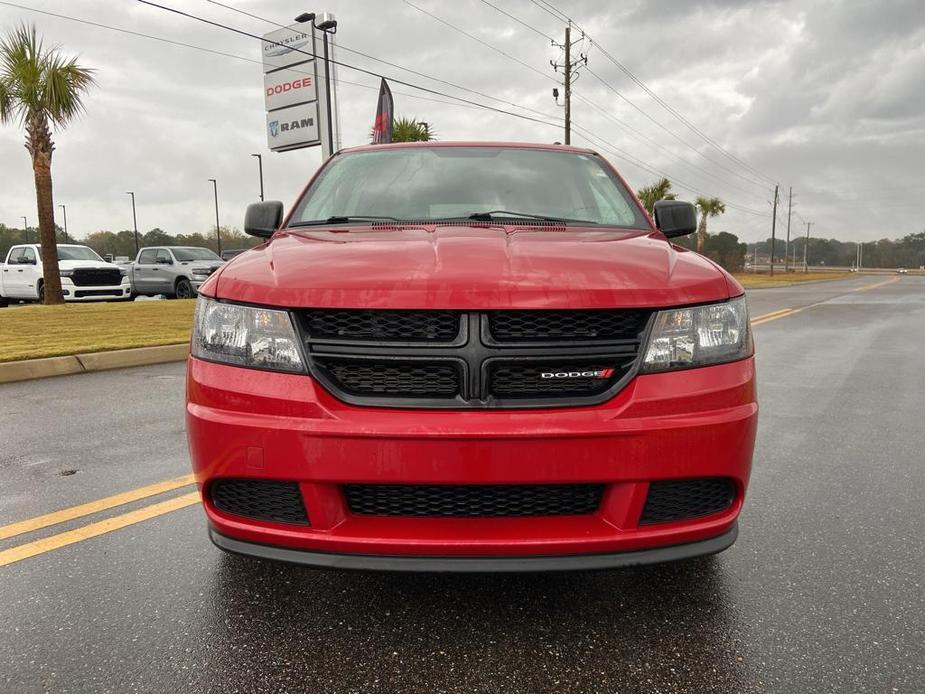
[210,479,309,525]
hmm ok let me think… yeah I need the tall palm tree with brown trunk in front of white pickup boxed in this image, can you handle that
[0,24,94,304]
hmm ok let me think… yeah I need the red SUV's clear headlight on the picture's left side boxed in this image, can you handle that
[191,296,305,372]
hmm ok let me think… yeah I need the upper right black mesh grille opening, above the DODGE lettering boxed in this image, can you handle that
[488,311,649,342]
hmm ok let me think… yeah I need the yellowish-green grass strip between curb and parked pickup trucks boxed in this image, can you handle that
[0,300,196,362]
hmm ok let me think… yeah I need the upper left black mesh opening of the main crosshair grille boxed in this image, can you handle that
[303,310,459,342]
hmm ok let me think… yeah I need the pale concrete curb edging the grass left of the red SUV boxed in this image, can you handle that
[0,342,189,383]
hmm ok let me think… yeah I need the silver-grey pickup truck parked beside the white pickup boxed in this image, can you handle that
[129,246,225,299]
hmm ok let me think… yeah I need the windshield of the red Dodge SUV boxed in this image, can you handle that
[289,147,649,229]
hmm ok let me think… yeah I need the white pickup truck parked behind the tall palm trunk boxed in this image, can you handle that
[0,244,132,306]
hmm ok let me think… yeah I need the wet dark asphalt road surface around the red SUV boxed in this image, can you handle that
[0,277,925,692]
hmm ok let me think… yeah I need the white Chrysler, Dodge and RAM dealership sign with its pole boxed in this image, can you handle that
[261,14,335,159]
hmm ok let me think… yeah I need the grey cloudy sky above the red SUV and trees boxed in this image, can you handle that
[0,0,925,241]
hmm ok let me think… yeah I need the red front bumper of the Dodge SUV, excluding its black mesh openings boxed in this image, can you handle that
[187,358,757,571]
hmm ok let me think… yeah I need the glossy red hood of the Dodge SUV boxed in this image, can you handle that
[209,225,741,310]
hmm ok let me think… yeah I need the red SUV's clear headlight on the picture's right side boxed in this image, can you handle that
[642,296,754,373]
